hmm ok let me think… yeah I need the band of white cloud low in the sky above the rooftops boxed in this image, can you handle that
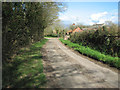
[59,12,118,25]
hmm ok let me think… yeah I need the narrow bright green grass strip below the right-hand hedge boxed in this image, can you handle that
[59,38,120,69]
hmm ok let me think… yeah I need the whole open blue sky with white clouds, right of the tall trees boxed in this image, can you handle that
[59,2,118,25]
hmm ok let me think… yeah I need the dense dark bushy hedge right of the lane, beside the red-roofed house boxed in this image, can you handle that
[70,27,120,57]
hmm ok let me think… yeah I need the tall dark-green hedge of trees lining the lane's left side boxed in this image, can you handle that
[2,2,62,61]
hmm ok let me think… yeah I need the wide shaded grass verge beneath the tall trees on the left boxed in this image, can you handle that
[2,39,47,88]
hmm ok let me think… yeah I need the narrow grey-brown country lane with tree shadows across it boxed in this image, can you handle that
[43,38,118,88]
